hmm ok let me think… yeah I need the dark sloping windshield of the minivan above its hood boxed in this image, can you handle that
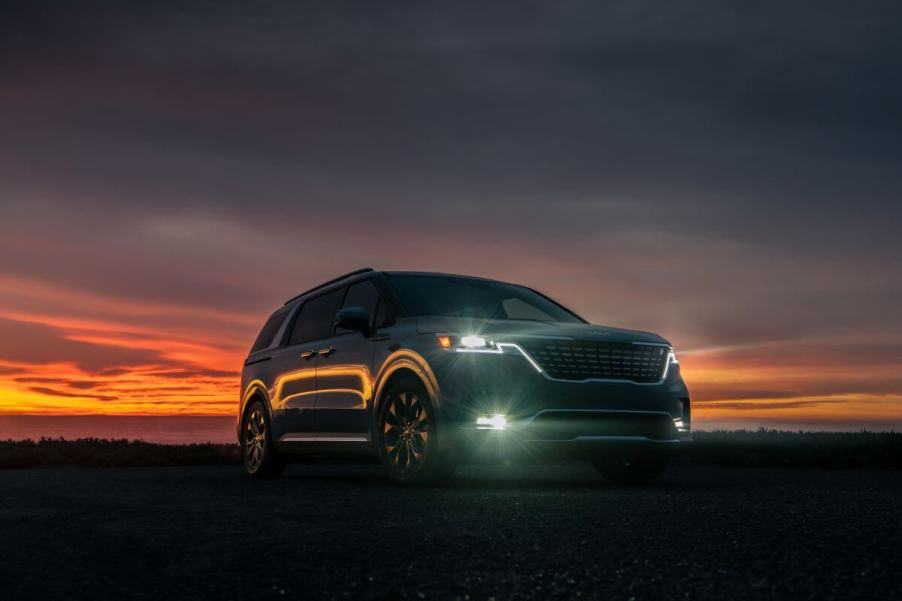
[388,275,585,323]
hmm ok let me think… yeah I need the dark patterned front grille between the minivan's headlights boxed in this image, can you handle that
[522,340,668,384]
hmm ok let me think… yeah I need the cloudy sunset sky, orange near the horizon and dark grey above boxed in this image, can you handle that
[0,0,902,429]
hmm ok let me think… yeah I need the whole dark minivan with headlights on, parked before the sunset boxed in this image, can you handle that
[238,269,691,483]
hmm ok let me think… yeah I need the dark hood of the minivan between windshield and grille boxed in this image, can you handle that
[417,317,670,344]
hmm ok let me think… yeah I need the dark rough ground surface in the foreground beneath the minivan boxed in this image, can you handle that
[0,464,902,600]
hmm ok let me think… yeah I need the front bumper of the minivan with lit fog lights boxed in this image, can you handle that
[436,355,691,461]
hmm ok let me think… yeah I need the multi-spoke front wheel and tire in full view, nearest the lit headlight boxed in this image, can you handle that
[376,376,456,484]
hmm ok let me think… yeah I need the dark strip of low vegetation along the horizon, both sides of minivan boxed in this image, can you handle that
[0,429,902,469]
